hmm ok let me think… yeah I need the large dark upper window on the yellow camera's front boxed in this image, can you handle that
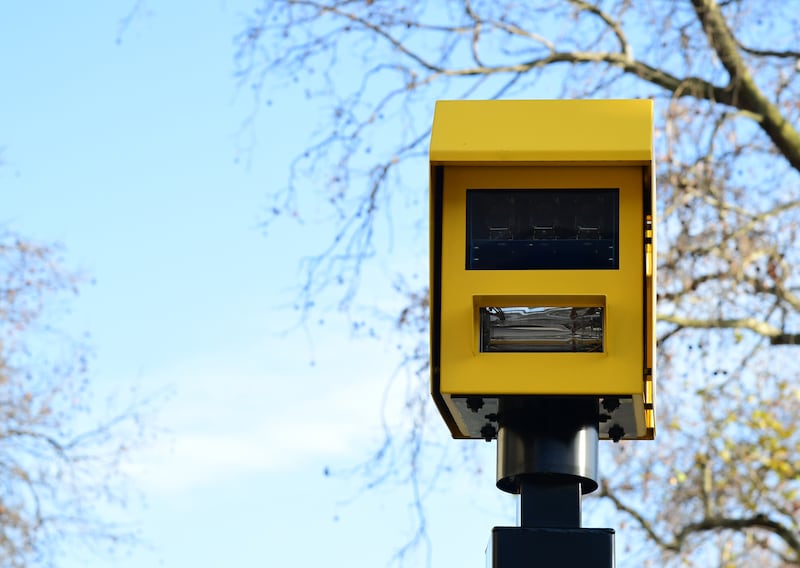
[467,189,619,270]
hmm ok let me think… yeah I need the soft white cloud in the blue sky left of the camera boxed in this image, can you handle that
[128,330,395,493]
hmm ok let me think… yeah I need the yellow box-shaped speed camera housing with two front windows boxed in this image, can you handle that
[430,100,655,440]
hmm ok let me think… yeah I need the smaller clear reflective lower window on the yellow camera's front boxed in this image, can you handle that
[480,306,603,353]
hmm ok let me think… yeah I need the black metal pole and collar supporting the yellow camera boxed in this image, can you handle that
[487,397,614,568]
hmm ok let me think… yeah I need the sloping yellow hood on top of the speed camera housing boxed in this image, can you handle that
[429,99,653,165]
